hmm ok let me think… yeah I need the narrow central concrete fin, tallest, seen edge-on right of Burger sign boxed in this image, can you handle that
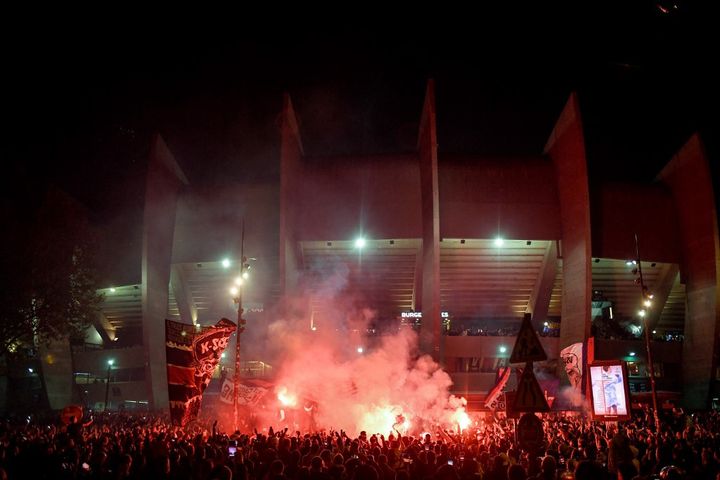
[418,80,442,361]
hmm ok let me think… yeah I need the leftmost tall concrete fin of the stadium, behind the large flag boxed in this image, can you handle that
[142,135,188,409]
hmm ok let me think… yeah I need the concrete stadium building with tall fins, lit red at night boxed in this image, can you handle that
[19,81,720,409]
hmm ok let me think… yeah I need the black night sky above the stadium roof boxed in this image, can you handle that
[3,1,720,223]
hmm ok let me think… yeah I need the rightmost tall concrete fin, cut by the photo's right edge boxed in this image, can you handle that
[659,134,720,409]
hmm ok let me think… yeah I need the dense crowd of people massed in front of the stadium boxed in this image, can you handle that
[0,407,720,480]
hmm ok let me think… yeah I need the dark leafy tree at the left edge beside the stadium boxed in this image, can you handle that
[0,189,102,356]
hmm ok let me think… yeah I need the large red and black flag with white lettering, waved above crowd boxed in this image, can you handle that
[165,318,236,426]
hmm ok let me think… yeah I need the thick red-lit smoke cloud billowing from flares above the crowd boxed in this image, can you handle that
[242,258,468,435]
